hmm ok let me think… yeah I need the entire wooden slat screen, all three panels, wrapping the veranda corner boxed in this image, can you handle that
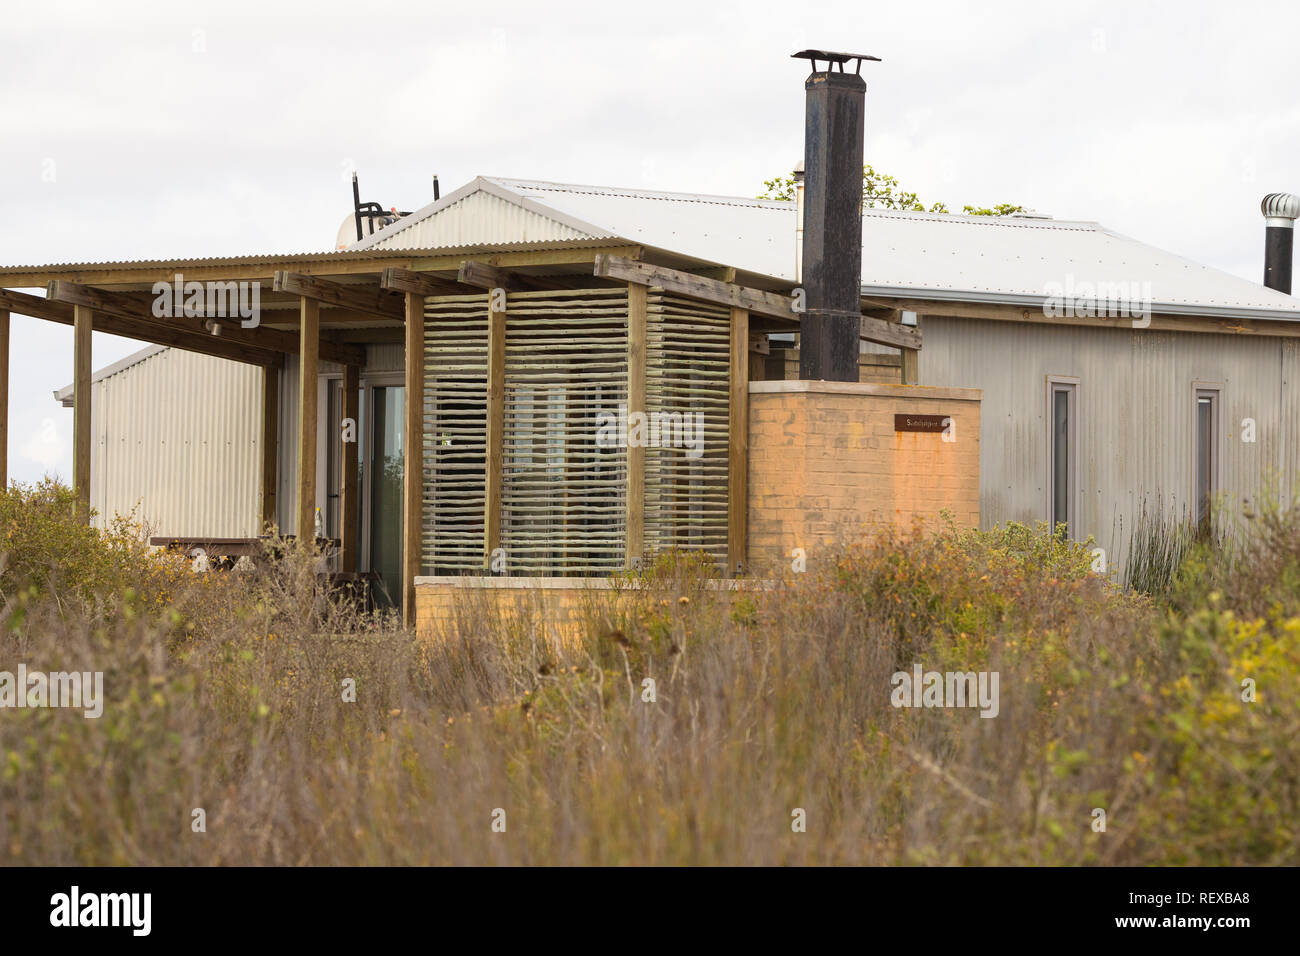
[423,287,729,576]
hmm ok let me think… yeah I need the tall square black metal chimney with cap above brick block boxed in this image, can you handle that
[794,49,879,381]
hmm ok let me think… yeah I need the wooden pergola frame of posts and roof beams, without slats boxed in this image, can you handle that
[0,241,920,624]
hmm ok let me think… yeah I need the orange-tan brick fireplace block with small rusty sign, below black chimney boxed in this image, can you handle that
[749,381,980,567]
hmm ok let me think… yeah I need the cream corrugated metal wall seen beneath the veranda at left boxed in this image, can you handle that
[91,349,261,537]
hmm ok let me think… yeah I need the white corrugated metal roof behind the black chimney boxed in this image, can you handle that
[348,177,1300,320]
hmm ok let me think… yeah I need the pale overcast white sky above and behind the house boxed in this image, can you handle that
[0,0,1300,481]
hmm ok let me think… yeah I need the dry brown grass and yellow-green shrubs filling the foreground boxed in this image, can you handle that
[0,486,1300,865]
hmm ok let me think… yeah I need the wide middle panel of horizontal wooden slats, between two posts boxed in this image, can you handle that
[501,289,628,576]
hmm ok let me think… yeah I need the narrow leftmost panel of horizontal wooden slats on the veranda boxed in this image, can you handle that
[423,294,488,575]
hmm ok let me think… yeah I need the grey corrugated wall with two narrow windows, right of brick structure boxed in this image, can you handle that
[920,316,1300,566]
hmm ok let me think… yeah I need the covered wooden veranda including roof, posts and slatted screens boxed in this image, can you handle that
[0,241,920,623]
